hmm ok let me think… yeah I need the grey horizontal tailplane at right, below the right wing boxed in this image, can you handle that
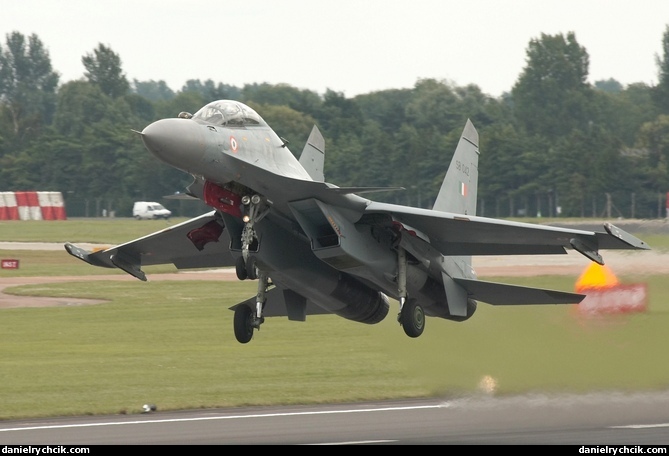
[453,278,585,306]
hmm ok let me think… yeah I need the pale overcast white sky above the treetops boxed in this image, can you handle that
[0,0,669,97]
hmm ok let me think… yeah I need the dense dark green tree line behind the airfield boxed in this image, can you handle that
[0,26,669,218]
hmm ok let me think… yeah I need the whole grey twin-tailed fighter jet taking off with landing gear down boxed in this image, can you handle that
[65,100,649,343]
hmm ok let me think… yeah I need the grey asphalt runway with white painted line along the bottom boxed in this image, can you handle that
[0,391,669,448]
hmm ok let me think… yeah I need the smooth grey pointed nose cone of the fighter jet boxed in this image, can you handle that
[142,119,205,172]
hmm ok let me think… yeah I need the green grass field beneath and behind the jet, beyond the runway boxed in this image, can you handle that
[0,219,669,419]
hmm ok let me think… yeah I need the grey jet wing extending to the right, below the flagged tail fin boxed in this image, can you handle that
[365,202,650,264]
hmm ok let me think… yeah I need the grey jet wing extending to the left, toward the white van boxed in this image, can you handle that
[65,211,235,280]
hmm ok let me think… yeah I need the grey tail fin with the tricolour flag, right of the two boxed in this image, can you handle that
[433,119,479,215]
